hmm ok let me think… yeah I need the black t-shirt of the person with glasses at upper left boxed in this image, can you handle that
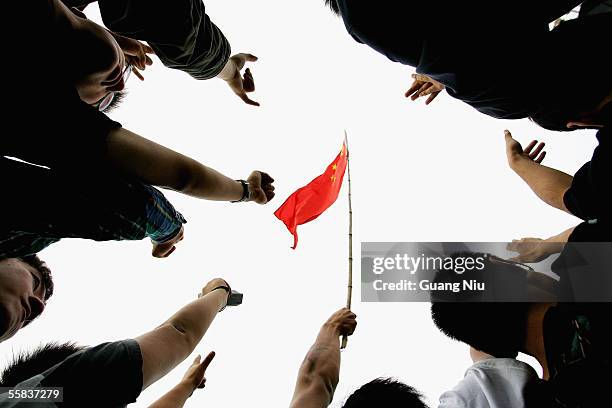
[0,0,121,174]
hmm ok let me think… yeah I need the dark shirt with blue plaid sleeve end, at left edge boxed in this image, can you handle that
[0,158,186,259]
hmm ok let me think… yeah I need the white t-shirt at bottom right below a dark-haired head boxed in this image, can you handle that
[439,358,538,408]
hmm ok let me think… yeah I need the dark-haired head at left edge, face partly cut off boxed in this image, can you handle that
[0,255,53,342]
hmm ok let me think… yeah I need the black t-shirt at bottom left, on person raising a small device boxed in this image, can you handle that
[0,340,143,408]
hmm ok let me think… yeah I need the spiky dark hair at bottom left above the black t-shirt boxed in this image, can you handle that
[0,343,85,387]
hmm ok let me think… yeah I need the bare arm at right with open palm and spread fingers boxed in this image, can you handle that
[504,130,573,213]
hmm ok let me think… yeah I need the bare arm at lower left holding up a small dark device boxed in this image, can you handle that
[136,279,229,390]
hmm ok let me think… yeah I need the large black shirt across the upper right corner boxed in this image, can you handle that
[338,0,611,119]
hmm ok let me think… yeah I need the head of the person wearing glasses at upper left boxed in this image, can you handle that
[66,8,129,111]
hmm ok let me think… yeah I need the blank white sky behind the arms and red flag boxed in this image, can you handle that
[0,0,596,407]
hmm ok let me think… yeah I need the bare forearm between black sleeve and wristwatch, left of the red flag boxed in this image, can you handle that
[107,128,243,201]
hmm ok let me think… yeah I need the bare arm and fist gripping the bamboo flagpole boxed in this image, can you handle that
[291,308,357,408]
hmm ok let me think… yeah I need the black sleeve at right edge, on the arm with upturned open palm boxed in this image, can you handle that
[563,103,612,220]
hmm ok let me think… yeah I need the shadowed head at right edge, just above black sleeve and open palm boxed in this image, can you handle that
[529,86,612,132]
